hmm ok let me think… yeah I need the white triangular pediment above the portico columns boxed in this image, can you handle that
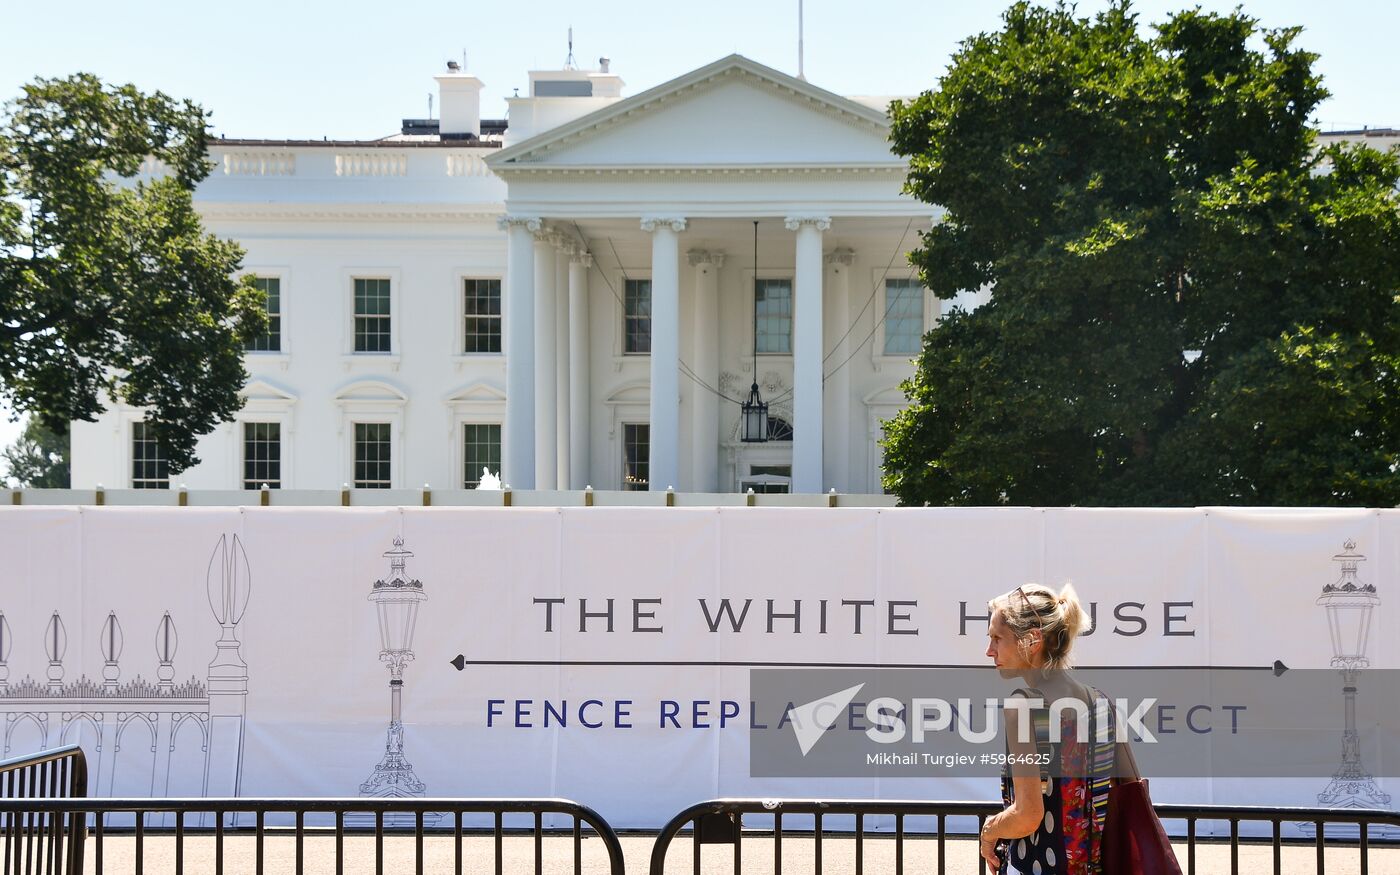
[487,55,900,175]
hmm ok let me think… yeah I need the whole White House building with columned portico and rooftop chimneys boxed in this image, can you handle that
[73,56,977,493]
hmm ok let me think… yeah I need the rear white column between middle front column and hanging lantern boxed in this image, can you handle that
[686,249,724,493]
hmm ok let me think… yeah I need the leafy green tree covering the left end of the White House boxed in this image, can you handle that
[0,74,266,470]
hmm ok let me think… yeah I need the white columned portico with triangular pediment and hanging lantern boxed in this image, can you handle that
[486,56,928,493]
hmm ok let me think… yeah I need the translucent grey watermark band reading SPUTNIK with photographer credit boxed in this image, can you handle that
[750,664,1400,777]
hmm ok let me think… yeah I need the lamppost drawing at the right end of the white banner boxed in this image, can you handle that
[1316,540,1400,834]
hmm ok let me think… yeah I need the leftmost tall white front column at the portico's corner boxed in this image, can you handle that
[492,216,540,489]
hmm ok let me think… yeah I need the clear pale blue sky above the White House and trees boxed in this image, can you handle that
[0,0,1400,464]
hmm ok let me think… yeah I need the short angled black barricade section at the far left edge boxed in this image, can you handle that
[0,745,87,875]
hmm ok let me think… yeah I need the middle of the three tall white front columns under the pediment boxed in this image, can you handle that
[641,217,686,491]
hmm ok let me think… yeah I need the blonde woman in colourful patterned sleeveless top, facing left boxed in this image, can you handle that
[980,584,1137,875]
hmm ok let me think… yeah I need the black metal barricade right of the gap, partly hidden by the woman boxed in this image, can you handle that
[651,799,1400,875]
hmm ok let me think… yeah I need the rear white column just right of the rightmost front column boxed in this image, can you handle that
[822,248,855,493]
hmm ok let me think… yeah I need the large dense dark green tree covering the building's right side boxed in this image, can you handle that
[885,3,1400,505]
